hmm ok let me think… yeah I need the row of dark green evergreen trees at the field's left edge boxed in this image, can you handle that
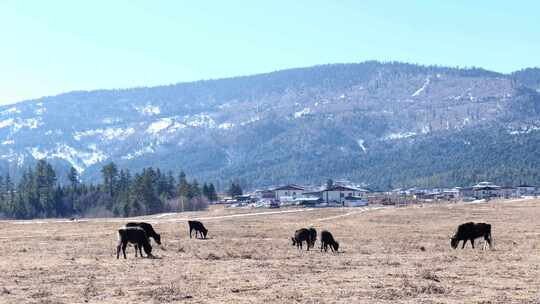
[0,160,218,219]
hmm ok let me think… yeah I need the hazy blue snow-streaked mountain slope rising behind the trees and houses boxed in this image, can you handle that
[0,62,540,186]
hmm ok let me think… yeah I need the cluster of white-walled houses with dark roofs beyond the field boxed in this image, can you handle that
[224,181,540,208]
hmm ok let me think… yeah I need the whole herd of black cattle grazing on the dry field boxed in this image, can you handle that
[116,221,492,259]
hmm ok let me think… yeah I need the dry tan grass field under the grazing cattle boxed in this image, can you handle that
[0,200,540,303]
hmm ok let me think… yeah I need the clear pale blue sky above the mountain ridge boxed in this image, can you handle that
[0,0,540,104]
